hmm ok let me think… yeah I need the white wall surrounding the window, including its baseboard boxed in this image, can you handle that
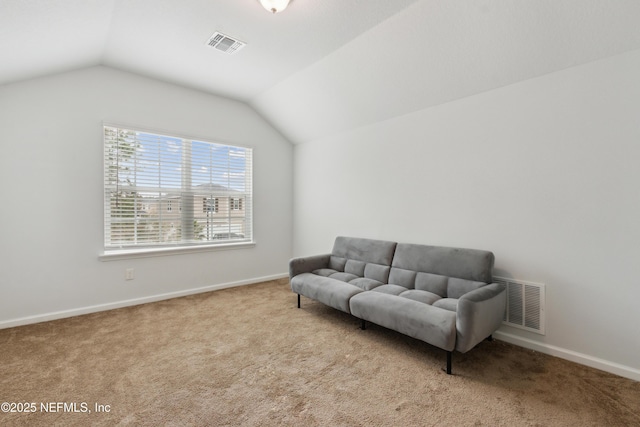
[0,67,292,327]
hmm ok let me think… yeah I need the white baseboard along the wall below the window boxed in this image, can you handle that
[0,273,289,329]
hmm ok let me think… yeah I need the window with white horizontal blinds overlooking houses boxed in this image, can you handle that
[104,126,253,252]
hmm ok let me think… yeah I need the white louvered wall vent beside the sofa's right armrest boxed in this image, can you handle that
[493,276,545,335]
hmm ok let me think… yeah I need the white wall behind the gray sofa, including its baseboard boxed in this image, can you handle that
[294,51,640,380]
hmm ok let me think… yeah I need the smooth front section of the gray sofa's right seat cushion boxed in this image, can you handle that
[349,292,456,351]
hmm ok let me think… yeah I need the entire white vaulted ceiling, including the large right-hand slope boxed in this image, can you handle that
[0,0,640,143]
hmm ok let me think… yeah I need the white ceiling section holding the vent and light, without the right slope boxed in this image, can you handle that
[0,0,415,101]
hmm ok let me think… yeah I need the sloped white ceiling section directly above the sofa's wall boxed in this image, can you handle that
[251,0,640,143]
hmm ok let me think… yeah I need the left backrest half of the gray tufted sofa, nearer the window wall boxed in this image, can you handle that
[329,236,396,283]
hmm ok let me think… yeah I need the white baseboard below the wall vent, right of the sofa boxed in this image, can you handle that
[493,331,640,381]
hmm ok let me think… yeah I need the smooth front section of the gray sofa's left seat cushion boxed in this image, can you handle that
[291,273,364,313]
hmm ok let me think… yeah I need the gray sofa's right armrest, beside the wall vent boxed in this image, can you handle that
[456,283,507,353]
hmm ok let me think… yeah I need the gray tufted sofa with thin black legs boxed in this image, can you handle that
[289,236,506,374]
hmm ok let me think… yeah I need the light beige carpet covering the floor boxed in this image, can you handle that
[0,280,640,426]
